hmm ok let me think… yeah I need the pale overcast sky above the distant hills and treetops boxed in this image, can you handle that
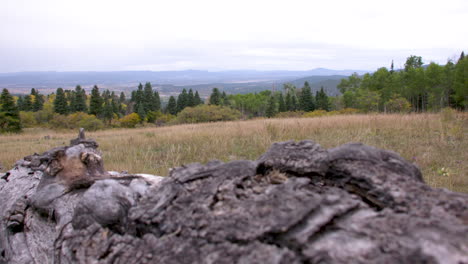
[0,0,468,72]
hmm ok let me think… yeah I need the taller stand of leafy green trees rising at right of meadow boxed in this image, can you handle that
[338,52,468,112]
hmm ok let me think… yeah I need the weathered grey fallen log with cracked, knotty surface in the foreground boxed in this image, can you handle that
[0,133,468,263]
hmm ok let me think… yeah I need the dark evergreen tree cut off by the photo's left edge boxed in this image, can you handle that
[0,89,22,133]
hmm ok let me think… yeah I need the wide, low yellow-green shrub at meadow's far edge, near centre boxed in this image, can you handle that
[177,105,241,123]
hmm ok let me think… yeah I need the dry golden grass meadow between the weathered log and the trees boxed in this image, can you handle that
[0,113,468,192]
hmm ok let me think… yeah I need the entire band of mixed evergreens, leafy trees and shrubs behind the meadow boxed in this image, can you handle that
[0,52,468,132]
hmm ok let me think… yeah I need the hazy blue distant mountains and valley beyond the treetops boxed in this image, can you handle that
[0,68,366,95]
